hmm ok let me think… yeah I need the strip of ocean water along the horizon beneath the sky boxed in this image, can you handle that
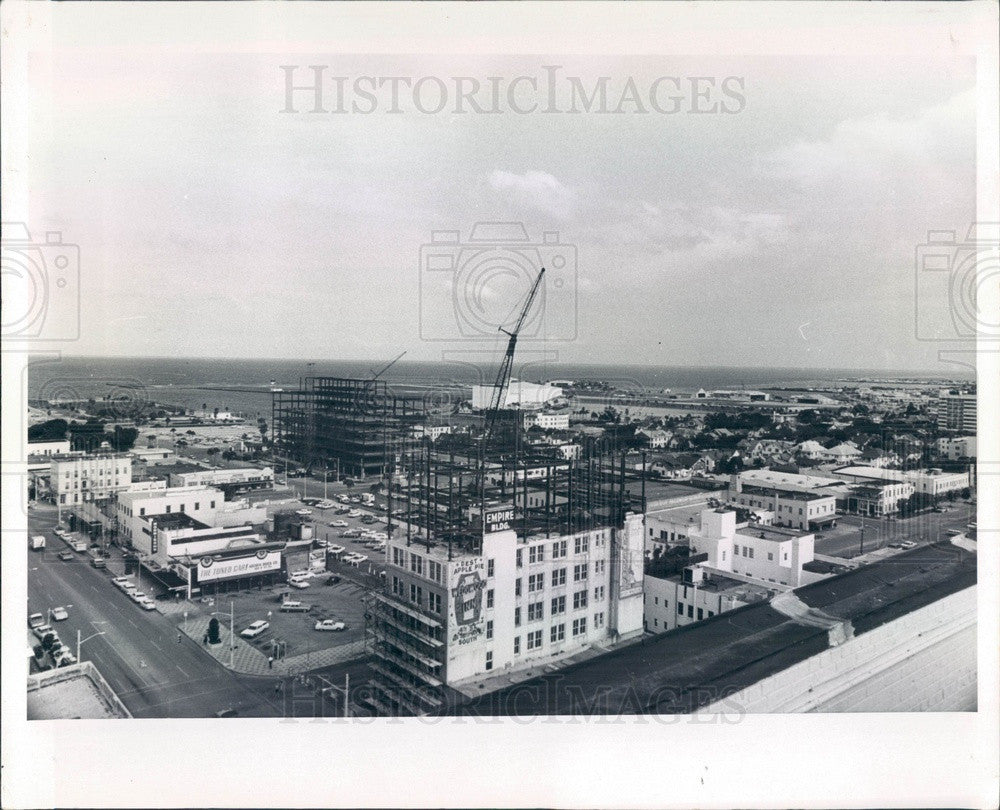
[28,357,968,419]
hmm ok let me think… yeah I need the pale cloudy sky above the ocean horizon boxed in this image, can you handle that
[28,47,976,370]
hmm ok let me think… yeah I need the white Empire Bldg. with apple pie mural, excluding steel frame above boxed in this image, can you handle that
[371,507,643,713]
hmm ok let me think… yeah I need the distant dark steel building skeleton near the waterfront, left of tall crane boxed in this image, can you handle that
[272,377,427,478]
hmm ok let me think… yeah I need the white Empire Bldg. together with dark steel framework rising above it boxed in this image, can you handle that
[366,438,644,715]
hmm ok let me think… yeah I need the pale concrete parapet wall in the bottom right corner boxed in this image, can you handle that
[697,586,977,714]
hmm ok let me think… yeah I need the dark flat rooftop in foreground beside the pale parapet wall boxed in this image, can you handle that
[444,542,976,717]
